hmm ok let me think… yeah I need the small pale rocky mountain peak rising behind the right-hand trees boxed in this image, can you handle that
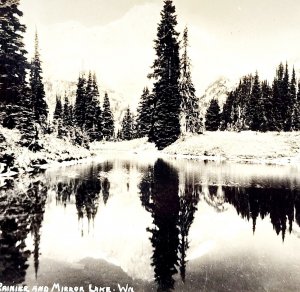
[199,77,237,113]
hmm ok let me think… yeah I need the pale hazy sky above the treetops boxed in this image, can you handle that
[20,0,300,99]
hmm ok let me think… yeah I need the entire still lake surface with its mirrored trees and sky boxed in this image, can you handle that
[0,157,300,291]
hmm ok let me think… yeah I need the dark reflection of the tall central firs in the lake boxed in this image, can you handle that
[139,159,199,291]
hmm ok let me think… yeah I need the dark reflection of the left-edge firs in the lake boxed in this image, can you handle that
[0,181,47,284]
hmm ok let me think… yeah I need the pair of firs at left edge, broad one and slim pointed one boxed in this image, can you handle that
[0,1,48,150]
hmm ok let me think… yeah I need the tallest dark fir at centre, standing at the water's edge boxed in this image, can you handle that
[149,0,180,149]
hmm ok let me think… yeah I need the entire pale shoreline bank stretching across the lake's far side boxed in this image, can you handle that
[0,128,300,177]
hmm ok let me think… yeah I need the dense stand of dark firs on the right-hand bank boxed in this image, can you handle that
[205,63,300,132]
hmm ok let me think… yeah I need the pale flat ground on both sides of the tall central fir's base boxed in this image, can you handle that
[91,131,300,164]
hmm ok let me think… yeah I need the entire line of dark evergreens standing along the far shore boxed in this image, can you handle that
[0,0,300,151]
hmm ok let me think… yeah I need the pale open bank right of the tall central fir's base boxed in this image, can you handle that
[163,131,300,164]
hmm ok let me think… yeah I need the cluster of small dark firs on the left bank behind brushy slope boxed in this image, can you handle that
[53,72,114,144]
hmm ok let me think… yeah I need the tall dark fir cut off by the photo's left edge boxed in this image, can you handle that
[0,0,36,146]
